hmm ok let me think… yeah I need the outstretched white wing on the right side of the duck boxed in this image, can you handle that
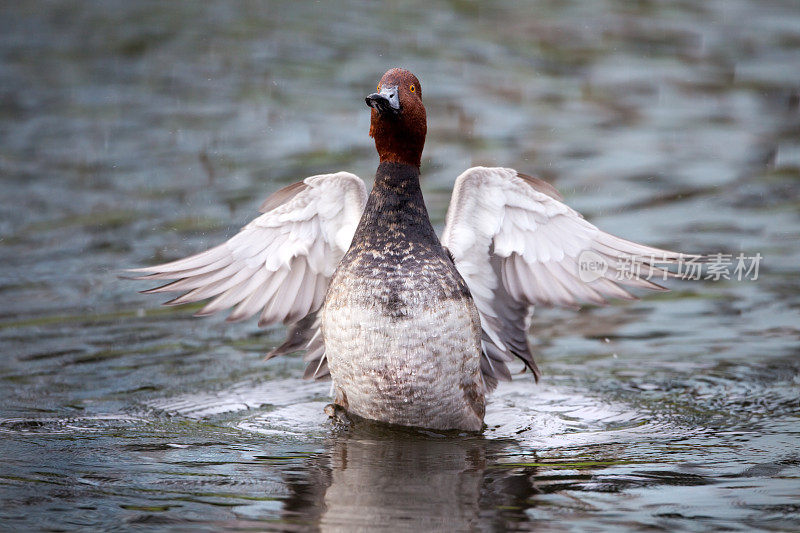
[442,167,694,389]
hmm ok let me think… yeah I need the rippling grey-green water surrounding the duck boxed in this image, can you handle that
[0,0,800,531]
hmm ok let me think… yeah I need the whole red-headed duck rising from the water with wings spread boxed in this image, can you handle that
[131,68,689,432]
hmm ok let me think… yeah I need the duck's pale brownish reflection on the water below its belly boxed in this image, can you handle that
[284,423,537,531]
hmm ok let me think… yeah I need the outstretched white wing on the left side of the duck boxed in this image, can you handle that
[131,172,367,377]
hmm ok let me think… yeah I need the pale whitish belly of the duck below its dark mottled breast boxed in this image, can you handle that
[322,288,484,430]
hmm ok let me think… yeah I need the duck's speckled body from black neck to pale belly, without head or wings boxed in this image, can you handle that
[322,163,484,430]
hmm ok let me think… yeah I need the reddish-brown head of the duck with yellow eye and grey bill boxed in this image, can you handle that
[366,68,428,167]
